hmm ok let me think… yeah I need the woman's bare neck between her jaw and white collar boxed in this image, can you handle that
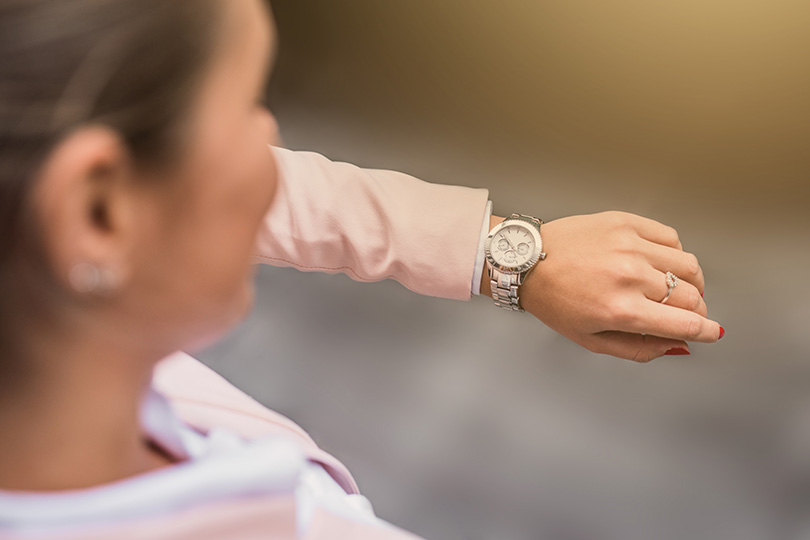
[0,324,175,491]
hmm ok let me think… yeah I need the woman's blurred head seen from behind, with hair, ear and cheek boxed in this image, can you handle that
[0,0,276,362]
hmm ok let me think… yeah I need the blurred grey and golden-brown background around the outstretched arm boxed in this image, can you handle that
[196,0,810,540]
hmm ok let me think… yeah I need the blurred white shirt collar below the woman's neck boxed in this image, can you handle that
[0,388,307,534]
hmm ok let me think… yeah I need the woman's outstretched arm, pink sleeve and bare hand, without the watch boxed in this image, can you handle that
[259,149,723,362]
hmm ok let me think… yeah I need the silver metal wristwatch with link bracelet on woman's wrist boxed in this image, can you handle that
[484,214,546,312]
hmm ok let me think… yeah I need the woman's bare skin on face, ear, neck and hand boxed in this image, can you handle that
[0,0,719,491]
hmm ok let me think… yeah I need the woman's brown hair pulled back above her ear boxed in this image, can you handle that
[0,0,216,350]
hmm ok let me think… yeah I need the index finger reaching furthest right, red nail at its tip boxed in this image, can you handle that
[616,300,721,343]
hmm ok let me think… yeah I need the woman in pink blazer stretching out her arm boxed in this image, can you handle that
[0,0,723,539]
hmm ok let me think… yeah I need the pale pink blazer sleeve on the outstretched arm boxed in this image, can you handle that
[257,148,489,300]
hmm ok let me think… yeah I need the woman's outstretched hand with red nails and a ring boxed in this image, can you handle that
[482,212,722,362]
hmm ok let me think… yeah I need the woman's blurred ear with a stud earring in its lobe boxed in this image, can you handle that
[33,126,135,292]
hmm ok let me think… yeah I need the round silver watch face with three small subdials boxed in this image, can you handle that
[484,220,542,273]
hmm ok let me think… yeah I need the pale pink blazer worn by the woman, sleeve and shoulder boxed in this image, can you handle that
[1,149,489,540]
